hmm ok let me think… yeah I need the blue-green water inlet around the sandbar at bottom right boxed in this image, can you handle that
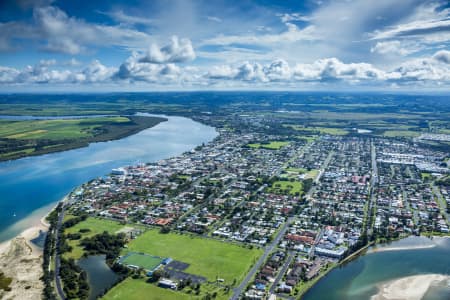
[303,237,450,300]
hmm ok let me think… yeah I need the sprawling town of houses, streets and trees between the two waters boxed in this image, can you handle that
[47,111,450,299]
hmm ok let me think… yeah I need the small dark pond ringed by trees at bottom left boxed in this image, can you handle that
[77,255,119,300]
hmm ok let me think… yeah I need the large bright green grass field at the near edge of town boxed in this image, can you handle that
[124,230,262,284]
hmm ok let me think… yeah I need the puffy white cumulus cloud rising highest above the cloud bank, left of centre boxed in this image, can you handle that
[139,36,195,64]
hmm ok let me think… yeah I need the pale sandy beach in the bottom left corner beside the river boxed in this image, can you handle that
[0,209,48,299]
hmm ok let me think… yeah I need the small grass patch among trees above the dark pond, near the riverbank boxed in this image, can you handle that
[64,215,125,259]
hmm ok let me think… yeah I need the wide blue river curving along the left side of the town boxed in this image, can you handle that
[0,114,218,242]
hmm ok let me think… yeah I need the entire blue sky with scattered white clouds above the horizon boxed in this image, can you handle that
[0,0,450,92]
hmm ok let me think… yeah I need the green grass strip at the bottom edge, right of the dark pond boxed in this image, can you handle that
[102,278,196,300]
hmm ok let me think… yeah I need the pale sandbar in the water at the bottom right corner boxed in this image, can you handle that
[371,274,449,300]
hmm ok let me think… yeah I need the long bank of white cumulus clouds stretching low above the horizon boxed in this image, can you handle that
[0,50,450,87]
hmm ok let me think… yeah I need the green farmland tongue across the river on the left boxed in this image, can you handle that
[0,116,165,160]
